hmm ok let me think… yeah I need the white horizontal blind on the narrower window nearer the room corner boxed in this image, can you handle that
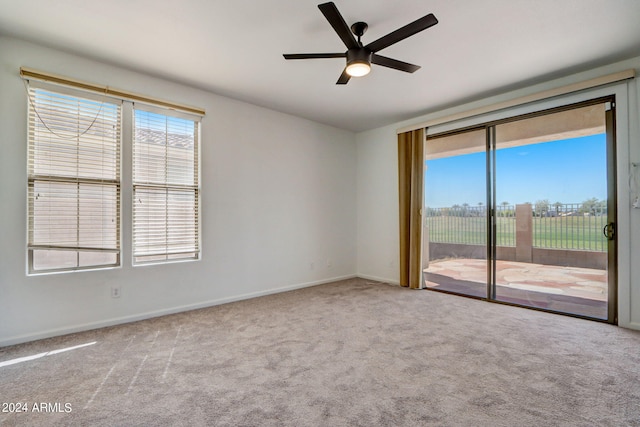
[133,106,200,264]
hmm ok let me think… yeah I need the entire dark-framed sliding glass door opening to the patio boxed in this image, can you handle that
[423,98,616,322]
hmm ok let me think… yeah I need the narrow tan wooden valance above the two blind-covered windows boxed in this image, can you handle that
[20,67,205,116]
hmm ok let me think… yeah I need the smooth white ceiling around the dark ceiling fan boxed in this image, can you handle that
[0,0,640,131]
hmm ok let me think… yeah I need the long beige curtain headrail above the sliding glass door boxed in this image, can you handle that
[396,69,636,134]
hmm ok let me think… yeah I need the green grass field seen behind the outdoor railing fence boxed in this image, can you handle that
[426,215,607,251]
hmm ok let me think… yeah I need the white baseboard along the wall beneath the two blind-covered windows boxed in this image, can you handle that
[0,274,358,347]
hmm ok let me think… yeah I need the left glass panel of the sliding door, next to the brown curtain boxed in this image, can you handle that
[423,129,489,297]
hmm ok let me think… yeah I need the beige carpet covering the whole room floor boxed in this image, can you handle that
[0,279,640,427]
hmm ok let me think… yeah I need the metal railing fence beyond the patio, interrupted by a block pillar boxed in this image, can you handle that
[425,203,607,252]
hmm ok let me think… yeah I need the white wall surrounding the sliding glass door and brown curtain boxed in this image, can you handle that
[356,57,640,329]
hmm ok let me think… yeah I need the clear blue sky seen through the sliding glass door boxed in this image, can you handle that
[425,134,607,208]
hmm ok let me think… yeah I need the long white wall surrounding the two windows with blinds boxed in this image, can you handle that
[0,38,357,346]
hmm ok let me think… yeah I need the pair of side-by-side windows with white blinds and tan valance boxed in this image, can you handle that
[20,67,205,274]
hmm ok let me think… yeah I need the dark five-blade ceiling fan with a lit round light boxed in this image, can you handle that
[284,2,438,85]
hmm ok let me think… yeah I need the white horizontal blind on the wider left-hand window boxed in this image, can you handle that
[28,86,121,272]
